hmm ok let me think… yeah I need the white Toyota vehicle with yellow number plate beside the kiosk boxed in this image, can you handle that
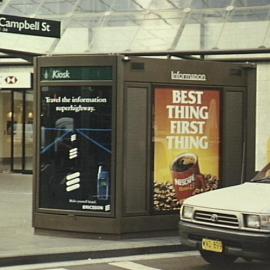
[179,163,270,266]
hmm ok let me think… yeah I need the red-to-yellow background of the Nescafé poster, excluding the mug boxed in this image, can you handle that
[154,88,220,210]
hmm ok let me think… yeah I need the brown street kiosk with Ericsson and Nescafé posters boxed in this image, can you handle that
[33,55,256,235]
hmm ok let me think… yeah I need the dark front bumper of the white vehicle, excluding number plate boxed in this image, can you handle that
[179,221,270,260]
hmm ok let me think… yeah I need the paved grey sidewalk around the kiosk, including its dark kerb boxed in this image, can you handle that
[0,173,184,266]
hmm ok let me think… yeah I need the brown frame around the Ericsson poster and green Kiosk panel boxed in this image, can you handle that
[33,57,116,217]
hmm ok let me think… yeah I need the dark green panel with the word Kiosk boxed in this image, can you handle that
[41,66,112,81]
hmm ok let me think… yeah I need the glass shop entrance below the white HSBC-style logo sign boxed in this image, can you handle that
[0,89,33,173]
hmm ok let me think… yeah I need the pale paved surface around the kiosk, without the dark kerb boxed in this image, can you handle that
[0,173,180,260]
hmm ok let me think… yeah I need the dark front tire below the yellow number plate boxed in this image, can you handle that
[200,250,237,267]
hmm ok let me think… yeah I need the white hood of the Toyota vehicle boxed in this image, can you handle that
[184,182,270,213]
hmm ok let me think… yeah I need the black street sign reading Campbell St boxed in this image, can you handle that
[0,14,61,38]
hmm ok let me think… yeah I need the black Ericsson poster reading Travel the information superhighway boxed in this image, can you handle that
[39,86,112,212]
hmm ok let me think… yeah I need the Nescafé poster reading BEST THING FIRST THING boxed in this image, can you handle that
[153,88,220,211]
